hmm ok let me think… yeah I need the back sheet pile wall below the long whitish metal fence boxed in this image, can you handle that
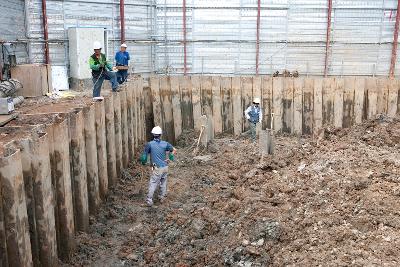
[146,76,400,142]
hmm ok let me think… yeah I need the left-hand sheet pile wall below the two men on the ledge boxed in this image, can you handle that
[0,77,145,267]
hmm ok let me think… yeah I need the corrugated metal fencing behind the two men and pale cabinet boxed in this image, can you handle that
[24,0,154,73]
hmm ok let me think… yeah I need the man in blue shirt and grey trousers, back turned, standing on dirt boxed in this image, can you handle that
[140,126,176,206]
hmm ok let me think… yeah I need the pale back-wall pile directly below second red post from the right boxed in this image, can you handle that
[322,78,335,125]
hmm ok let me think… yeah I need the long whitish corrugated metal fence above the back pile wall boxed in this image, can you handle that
[155,0,400,75]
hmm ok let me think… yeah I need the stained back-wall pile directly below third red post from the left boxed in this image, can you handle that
[179,76,194,129]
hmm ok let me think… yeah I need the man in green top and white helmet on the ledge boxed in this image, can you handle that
[89,42,118,98]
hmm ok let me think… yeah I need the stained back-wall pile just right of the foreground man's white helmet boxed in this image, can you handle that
[160,76,175,144]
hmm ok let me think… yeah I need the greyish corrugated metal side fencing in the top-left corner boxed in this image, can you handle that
[0,0,29,64]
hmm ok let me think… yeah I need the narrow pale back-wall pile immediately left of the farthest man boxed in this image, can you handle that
[232,76,243,136]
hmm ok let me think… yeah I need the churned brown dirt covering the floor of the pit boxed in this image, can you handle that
[66,117,400,267]
